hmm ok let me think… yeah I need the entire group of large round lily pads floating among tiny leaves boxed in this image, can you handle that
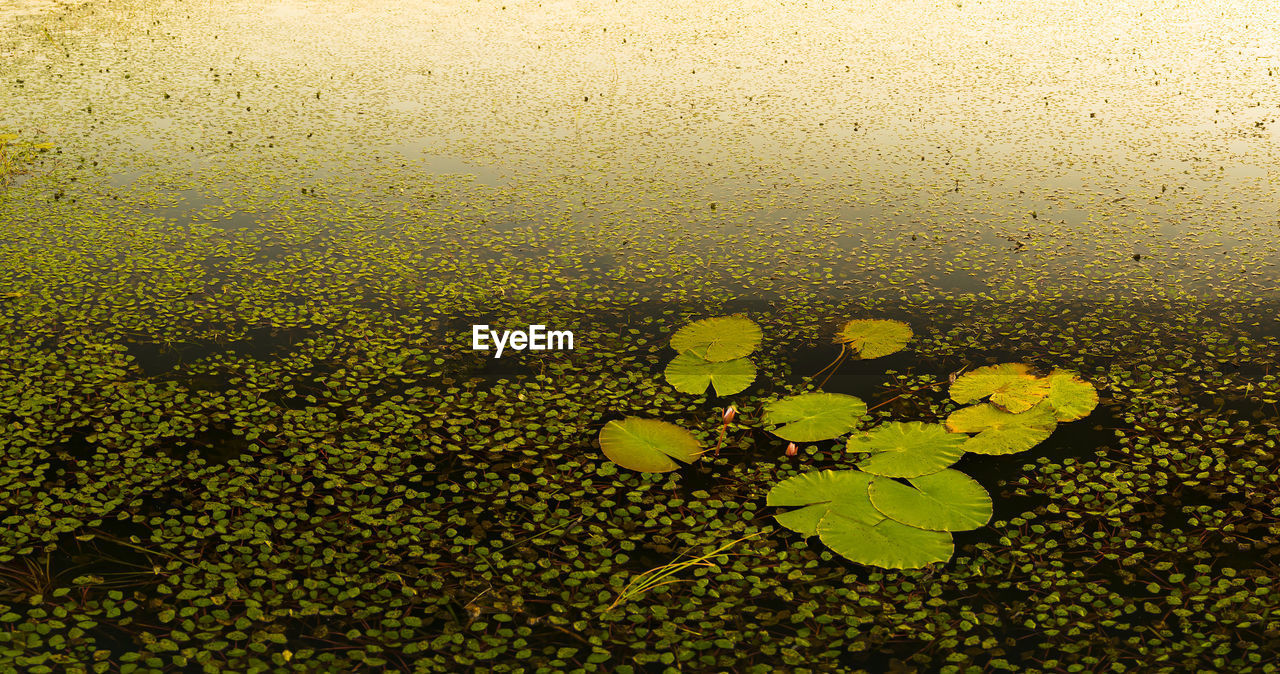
[600,316,1098,569]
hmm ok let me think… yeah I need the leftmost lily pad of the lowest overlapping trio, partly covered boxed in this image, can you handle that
[764,471,884,536]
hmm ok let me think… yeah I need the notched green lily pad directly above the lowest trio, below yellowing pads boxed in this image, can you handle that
[845,421,965,477]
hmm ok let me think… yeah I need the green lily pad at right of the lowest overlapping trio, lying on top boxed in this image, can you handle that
[867,469,991,531]
